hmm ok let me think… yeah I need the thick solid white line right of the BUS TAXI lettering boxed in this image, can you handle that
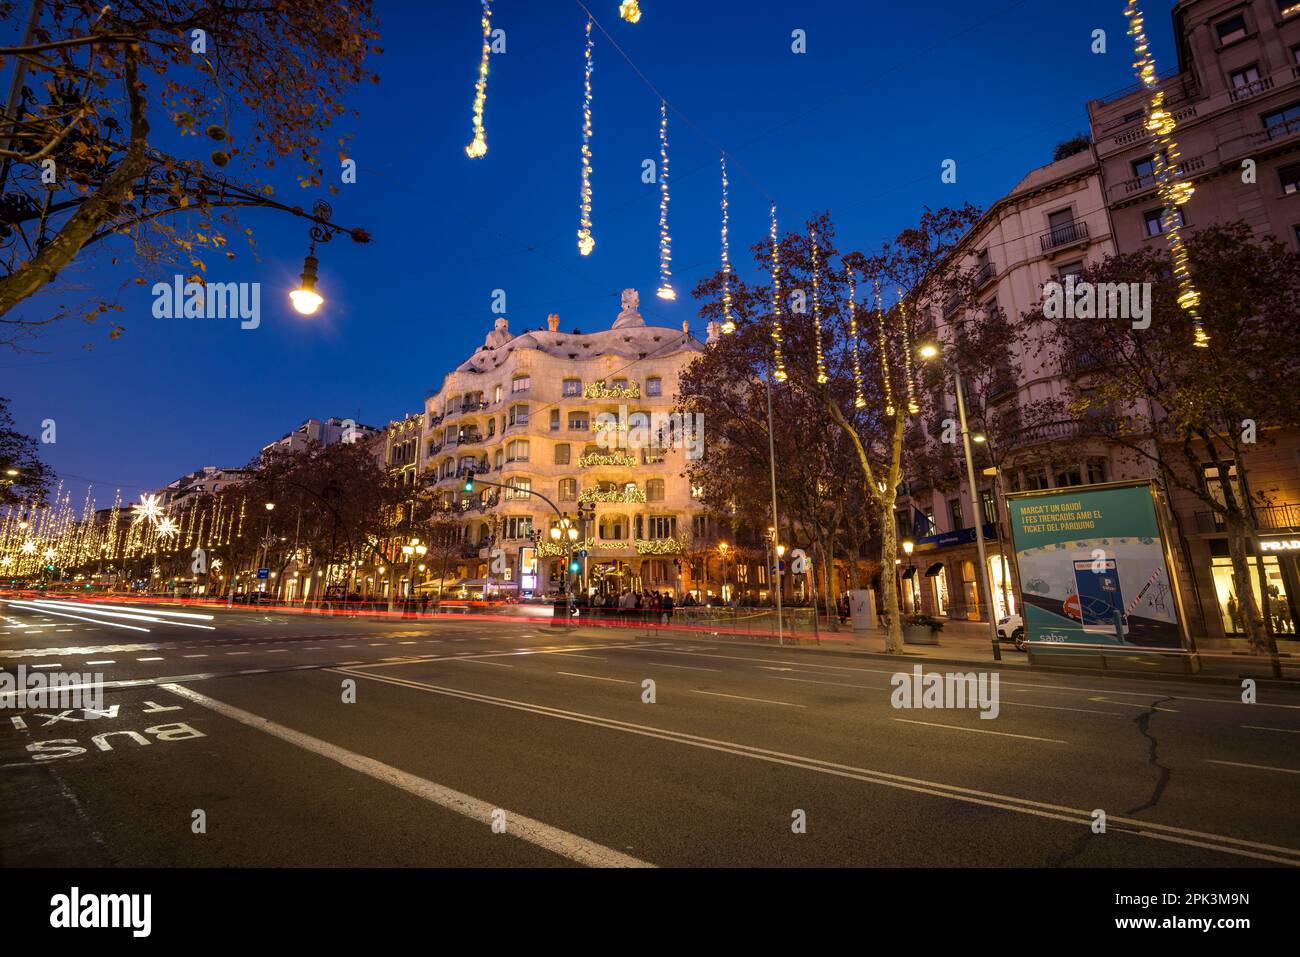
[161,684,654,867]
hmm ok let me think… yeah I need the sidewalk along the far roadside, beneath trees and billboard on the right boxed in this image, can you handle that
[564,613,1300,688]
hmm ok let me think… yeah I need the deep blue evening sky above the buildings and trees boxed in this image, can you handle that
[0,0,1175,505]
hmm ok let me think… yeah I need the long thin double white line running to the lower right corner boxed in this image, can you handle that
[329,667,1300,867]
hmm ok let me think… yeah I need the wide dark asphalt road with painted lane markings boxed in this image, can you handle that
[0,602,1300,867]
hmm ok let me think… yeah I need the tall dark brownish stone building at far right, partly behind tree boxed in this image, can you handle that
[1088,0,1300,638]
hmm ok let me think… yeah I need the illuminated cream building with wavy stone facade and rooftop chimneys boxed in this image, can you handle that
[405,290,703,594]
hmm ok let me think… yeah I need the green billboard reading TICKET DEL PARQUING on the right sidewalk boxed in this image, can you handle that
[1006,482,1183,649]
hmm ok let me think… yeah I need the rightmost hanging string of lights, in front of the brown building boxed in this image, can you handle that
[1125,0,1210,348]
